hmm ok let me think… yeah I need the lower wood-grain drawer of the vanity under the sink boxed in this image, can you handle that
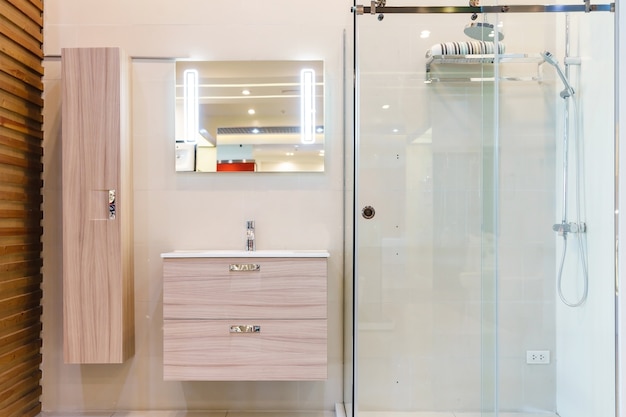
[163,319,327,381]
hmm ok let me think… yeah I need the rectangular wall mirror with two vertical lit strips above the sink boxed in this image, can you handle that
[175,61,324,172]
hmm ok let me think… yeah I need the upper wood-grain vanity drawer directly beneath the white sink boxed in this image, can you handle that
[163,258,327,319]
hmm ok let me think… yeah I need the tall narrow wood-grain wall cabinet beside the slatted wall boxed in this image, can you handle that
[61,48,134,363]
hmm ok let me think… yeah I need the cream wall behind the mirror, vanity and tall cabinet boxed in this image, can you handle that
[42,0,352,411]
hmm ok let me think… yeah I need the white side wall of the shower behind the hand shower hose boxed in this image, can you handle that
[556,9,615,417]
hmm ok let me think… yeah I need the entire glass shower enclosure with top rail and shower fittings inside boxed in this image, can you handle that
[346,0,616,417]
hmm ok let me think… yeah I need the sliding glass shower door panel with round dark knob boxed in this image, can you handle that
[355,10,496,415]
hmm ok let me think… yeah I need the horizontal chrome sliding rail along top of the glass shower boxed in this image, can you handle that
[352,2,615,15]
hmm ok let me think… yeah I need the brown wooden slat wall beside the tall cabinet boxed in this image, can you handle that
[0,0,43,417]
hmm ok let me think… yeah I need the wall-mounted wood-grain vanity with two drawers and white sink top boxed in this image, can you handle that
[162,251,328,381]
